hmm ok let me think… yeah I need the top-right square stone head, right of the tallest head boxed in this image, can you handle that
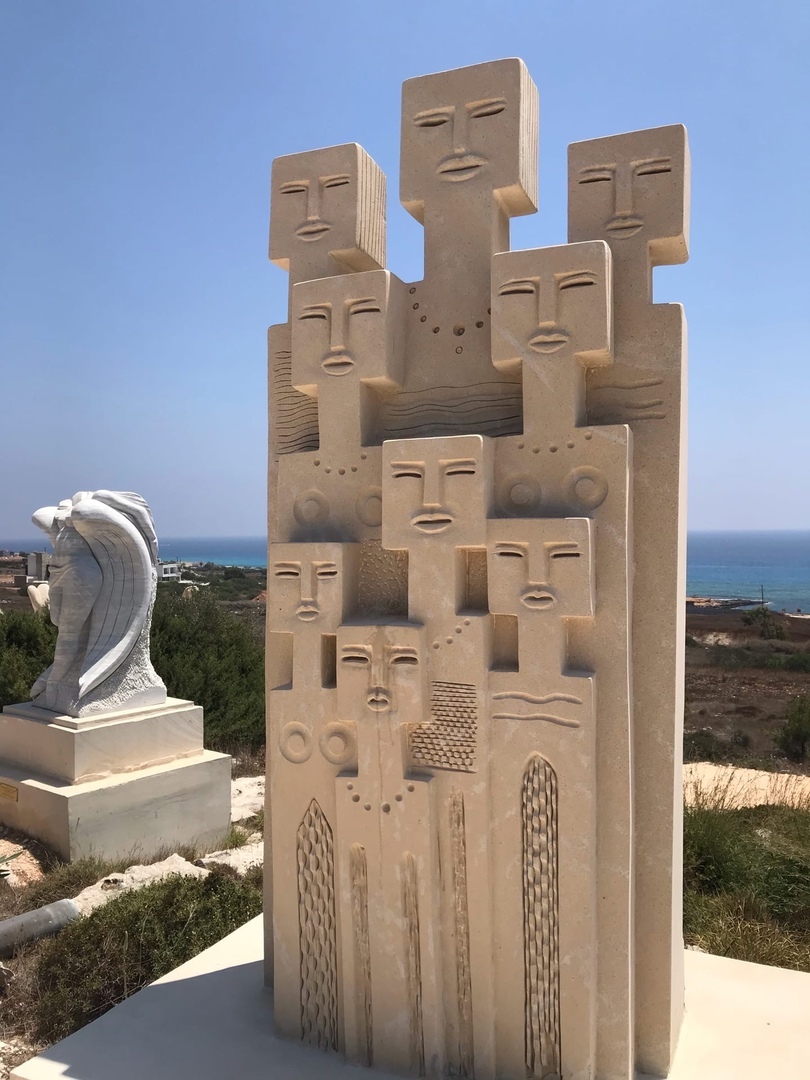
[568,124,689,266]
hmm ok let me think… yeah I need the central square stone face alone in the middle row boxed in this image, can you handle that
[382,435,492,549]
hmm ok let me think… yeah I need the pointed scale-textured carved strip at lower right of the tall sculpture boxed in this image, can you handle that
[523,754,562,1078]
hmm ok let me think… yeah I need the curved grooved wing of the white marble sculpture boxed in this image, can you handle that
[70,491,158,697]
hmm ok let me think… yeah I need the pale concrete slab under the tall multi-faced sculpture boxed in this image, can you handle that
[10,918,810,1080]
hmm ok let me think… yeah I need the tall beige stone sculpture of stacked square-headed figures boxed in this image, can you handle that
[266,59,689,1080]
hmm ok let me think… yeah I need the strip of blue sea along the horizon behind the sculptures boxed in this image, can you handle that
[0,530,810,612]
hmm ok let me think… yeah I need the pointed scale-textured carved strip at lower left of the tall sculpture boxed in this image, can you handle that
[296,799,337,1050]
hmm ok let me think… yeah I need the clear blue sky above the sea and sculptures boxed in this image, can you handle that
[0,0,810,539]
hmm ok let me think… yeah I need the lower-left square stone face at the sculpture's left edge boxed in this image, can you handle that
[267,543,357,632]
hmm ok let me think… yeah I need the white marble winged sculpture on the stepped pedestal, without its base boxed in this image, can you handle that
[31,490,166,717]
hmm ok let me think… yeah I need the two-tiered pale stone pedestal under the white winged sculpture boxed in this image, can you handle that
[0,698,231,861]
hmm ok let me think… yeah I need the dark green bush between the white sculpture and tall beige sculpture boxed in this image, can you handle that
[151,589,265,753]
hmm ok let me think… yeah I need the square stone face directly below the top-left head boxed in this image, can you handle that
[292,270,405,392]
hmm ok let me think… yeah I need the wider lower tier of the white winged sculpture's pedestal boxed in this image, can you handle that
[0,751,231,862]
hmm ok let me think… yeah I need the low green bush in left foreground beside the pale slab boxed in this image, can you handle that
[35,873,261,1042]
